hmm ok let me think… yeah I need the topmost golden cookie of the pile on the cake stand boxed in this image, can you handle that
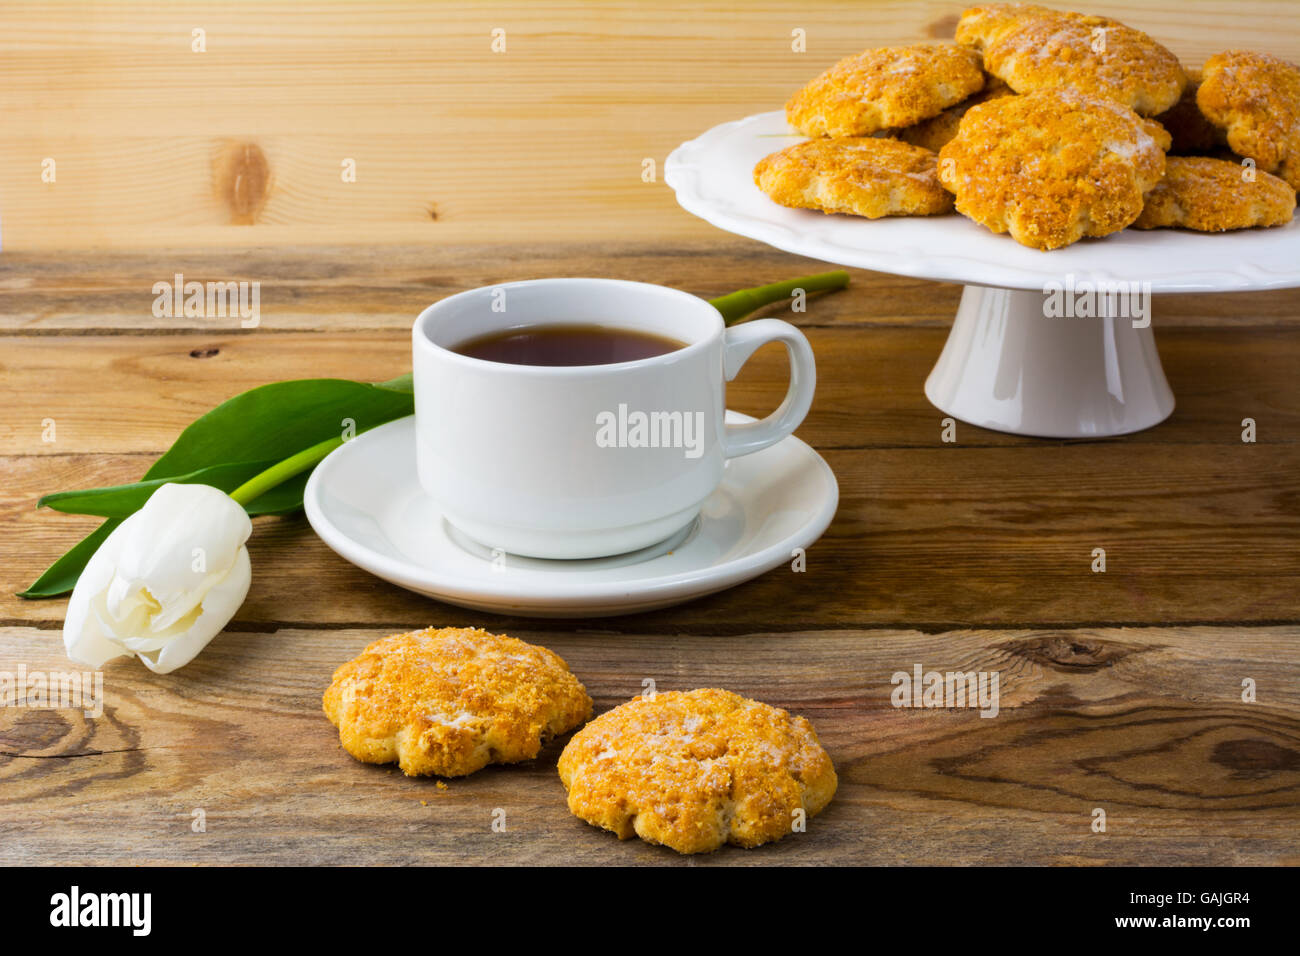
[957,4,1187,116]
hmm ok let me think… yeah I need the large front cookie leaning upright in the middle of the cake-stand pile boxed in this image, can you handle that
[939,88,1169,250]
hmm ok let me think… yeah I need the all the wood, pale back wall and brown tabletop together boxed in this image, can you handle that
[0,1,1300,865]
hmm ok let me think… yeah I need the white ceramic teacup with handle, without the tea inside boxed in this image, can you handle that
[412,278,816,558]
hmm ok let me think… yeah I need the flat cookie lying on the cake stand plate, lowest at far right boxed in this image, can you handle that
[1134,156,1296,233]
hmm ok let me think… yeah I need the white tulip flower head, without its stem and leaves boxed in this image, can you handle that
[64,484,252,674]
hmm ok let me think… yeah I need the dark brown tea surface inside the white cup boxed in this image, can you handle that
[451,324,685,365]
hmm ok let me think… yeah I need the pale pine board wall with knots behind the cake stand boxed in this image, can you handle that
[0,0,1300,250]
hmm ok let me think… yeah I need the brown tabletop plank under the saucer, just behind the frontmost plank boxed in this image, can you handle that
[10,442,1300,635]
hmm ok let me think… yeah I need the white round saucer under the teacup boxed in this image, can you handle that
[303,411,840,618]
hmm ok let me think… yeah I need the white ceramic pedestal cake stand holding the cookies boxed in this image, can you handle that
[664,112,1300,438]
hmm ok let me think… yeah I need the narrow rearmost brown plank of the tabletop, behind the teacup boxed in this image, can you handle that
[0,243,1300,336]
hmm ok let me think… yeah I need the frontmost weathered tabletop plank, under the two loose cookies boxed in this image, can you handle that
[0,626,1300,865]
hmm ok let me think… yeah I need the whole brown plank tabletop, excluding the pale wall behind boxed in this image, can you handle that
[0,238,1300,865]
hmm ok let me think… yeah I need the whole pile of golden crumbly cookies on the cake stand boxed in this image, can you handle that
[754,4,1300,250]
